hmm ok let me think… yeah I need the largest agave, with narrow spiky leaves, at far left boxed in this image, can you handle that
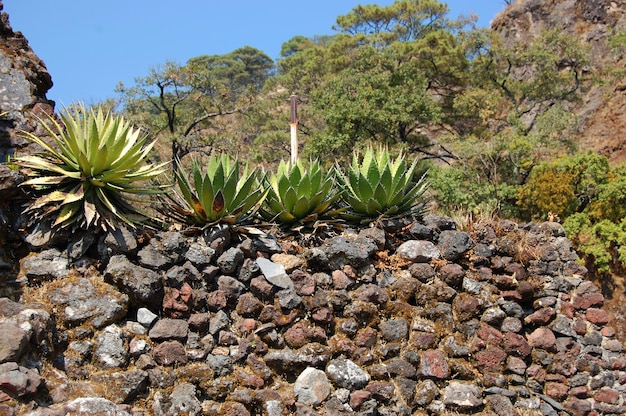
[16,105,166,230]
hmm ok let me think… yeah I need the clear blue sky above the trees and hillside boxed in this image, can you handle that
[3,0,504,107]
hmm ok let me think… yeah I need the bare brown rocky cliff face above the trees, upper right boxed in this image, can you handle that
[492,0,626,163]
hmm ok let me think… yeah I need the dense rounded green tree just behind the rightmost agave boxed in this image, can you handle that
[311,40,440,152]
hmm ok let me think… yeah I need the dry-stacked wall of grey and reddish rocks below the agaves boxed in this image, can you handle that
[0,215,626,416]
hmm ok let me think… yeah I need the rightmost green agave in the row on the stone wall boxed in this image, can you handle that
[337,147,428,223]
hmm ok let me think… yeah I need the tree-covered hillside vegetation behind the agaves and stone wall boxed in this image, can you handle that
[103,0,626,276]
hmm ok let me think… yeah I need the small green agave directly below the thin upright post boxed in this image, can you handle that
[261,161,339,224]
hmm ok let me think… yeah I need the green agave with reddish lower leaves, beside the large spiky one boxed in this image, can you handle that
[164,154,267,226]
